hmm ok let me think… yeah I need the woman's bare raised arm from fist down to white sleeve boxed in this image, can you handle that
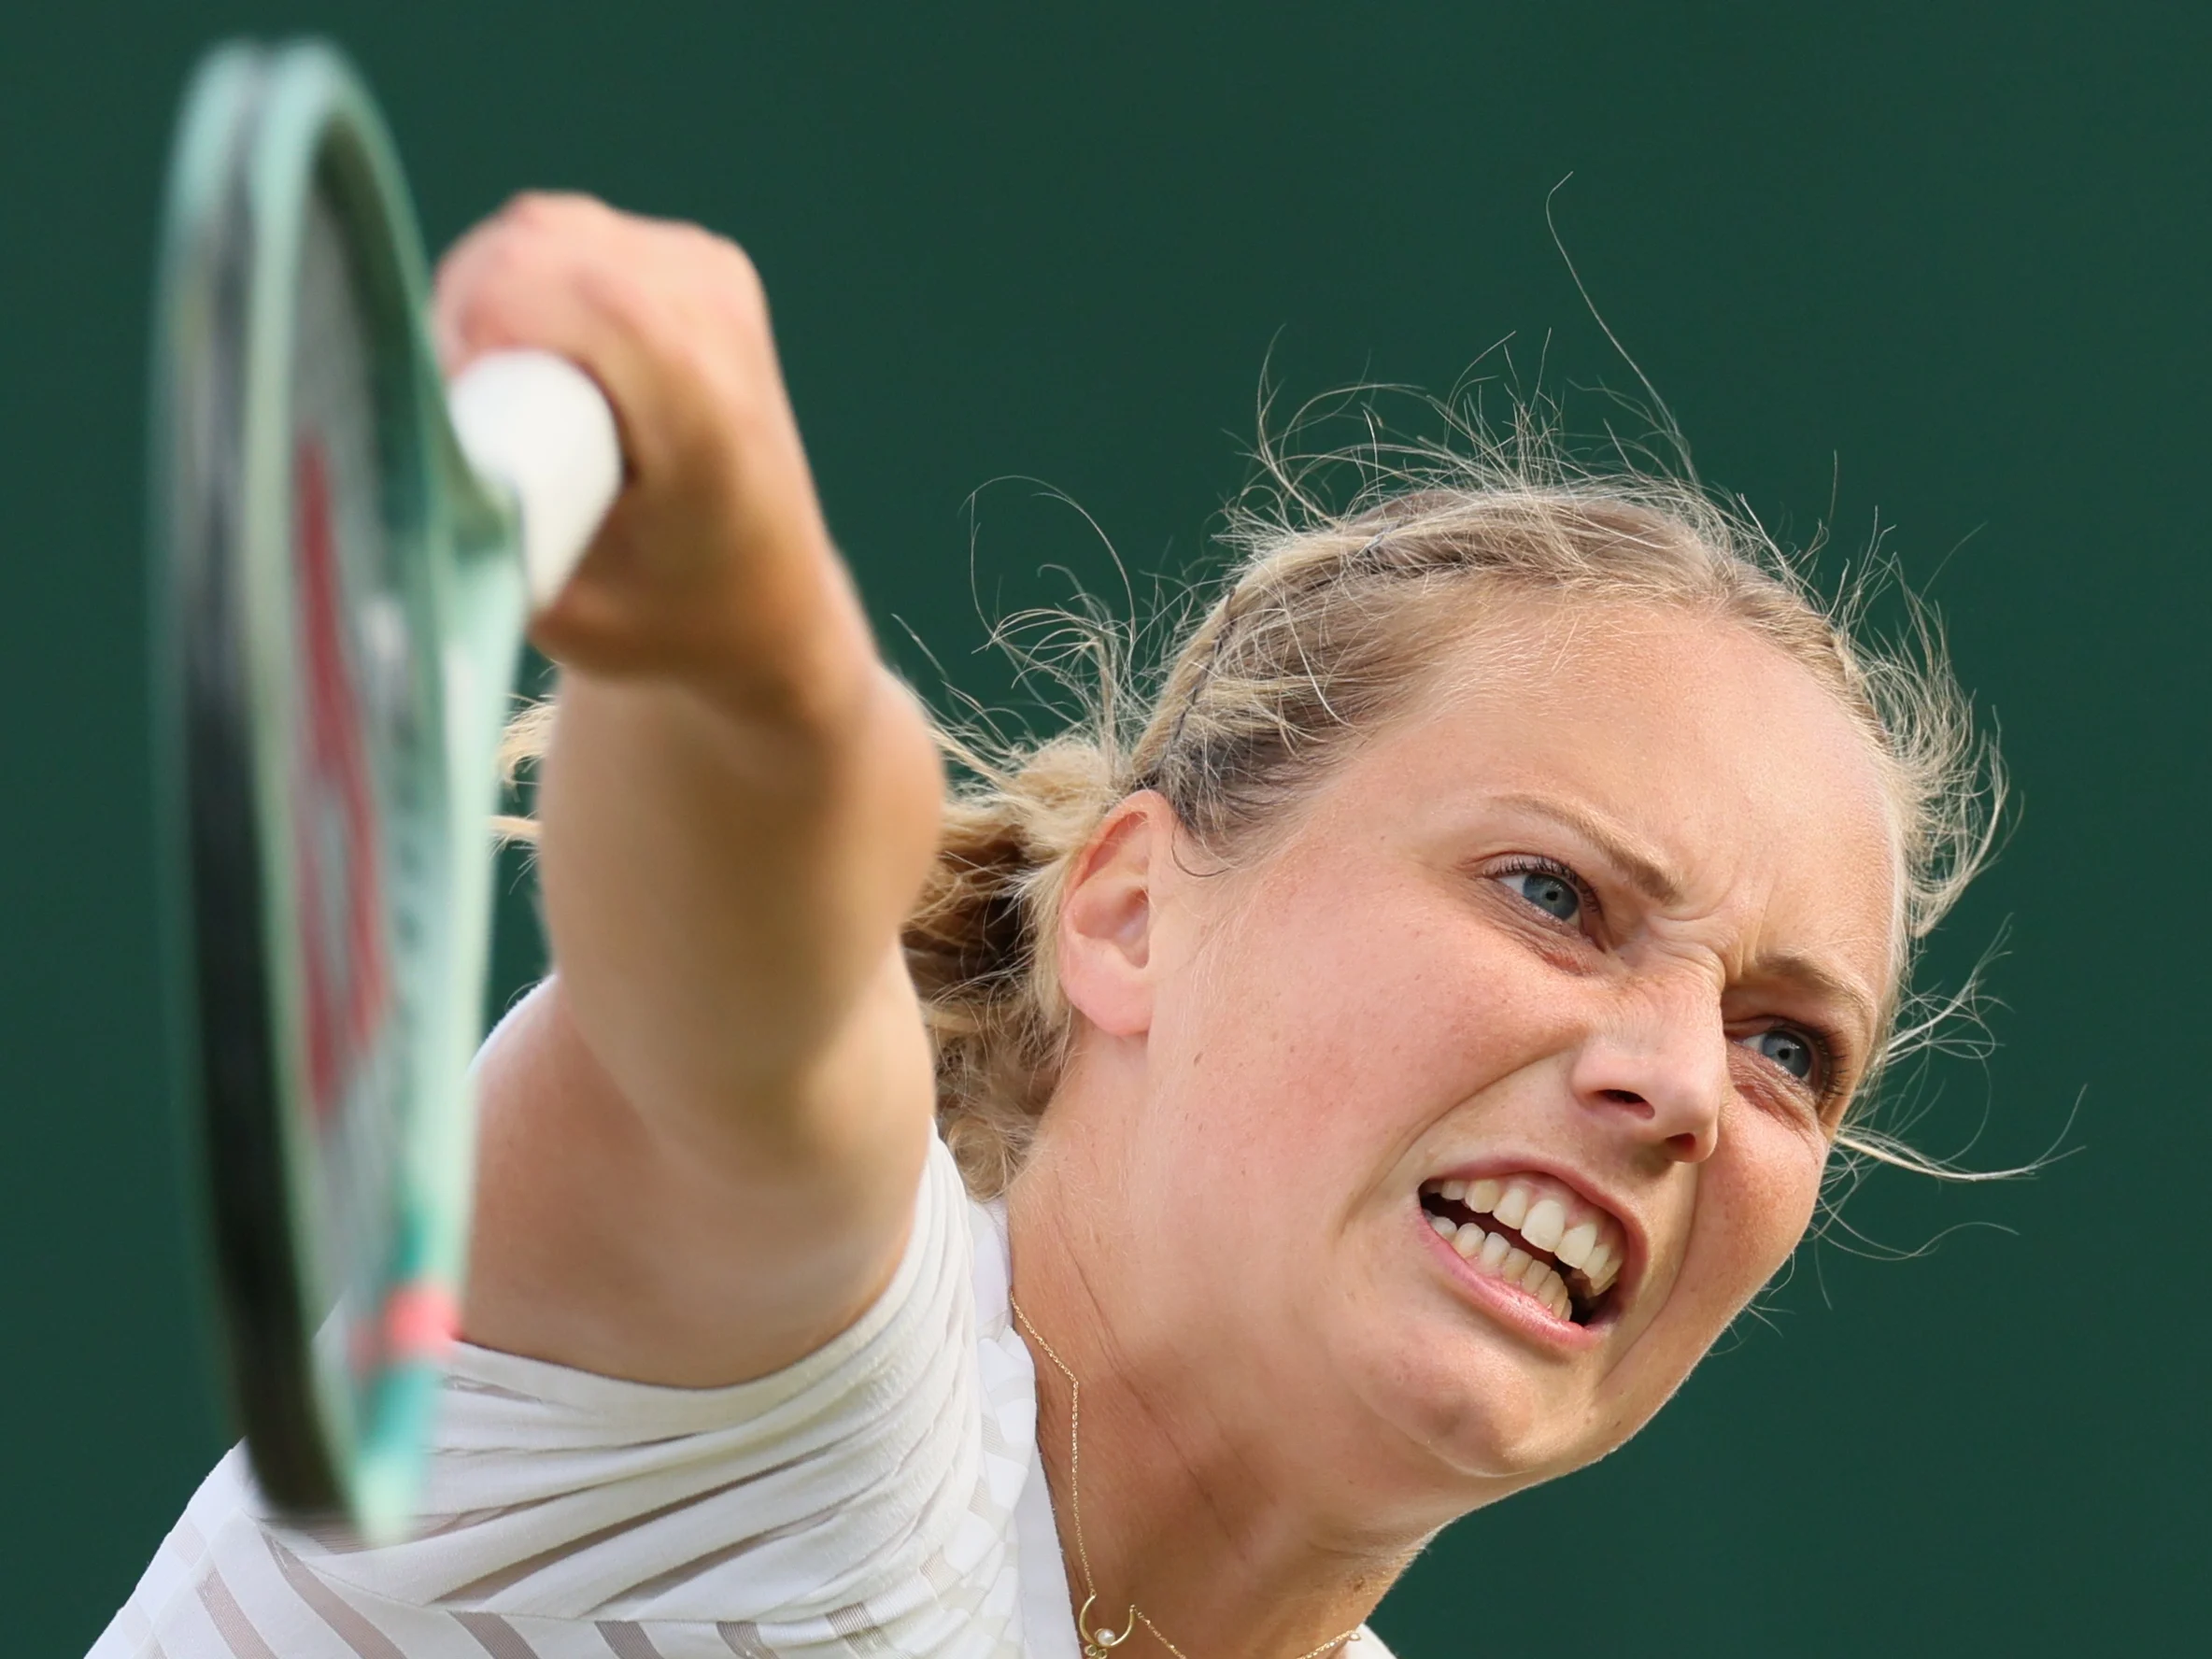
[438,197,943,1387]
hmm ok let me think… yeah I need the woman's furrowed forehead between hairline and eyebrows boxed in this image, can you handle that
[1329,602,1895,991]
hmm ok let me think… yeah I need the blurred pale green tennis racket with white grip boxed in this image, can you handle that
[150,44,621,1539]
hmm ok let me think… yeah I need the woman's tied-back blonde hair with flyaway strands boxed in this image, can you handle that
[509,411,2004,1197]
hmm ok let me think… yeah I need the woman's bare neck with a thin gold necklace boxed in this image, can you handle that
[1009,1159,1420,1659]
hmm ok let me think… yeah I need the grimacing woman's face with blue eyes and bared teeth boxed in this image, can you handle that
[1046,606,1895,1520]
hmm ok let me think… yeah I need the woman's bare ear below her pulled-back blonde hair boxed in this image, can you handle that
[1059,789,1177,1038]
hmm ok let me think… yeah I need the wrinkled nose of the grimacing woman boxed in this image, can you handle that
[1568,982,1735,1164]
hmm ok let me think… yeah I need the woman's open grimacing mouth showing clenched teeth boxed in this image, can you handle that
[1420,1174,1628,1325]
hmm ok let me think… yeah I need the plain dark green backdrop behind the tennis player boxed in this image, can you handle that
[0,0,2212,1659]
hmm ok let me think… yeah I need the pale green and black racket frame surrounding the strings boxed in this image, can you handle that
[150,42,527,1539]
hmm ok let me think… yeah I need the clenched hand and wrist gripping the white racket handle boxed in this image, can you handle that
[435,194,872,715]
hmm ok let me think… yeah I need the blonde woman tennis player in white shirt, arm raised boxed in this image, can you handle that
[92,197,1991,1659]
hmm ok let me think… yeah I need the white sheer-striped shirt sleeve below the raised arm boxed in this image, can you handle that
[92,1143,1015,1654]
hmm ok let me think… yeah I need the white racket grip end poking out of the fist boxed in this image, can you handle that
[447,352,621,611]
